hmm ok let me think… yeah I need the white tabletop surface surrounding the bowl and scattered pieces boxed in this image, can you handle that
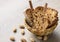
[0,0,60,42]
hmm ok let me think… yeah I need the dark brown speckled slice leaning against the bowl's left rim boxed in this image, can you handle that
[24,9,33,27]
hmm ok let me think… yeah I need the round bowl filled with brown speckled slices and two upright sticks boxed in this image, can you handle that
[24,1,58,40]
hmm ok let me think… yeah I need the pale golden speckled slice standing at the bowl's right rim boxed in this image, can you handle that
[46,8,58,27]
